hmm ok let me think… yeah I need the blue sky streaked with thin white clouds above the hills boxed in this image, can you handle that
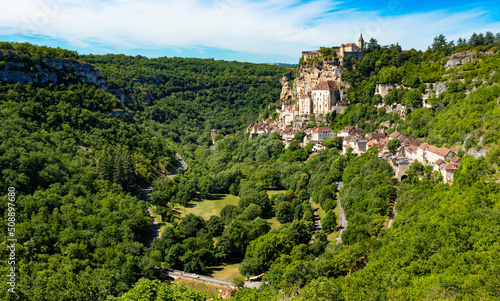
[0,0,500,64]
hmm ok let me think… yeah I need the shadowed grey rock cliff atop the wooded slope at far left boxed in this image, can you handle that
[0,51,106,90]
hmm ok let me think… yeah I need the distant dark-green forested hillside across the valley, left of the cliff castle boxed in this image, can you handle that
[81,55,286,149]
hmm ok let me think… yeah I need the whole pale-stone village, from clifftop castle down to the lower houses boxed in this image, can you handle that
[247,35,460,183]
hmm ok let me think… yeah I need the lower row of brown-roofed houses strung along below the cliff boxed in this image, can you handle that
[248,120,460,183]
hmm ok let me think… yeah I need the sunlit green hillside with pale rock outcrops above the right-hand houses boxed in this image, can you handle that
[334,37,500,151]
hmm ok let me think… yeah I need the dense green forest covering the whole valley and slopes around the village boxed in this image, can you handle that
[0,33,500,300]
